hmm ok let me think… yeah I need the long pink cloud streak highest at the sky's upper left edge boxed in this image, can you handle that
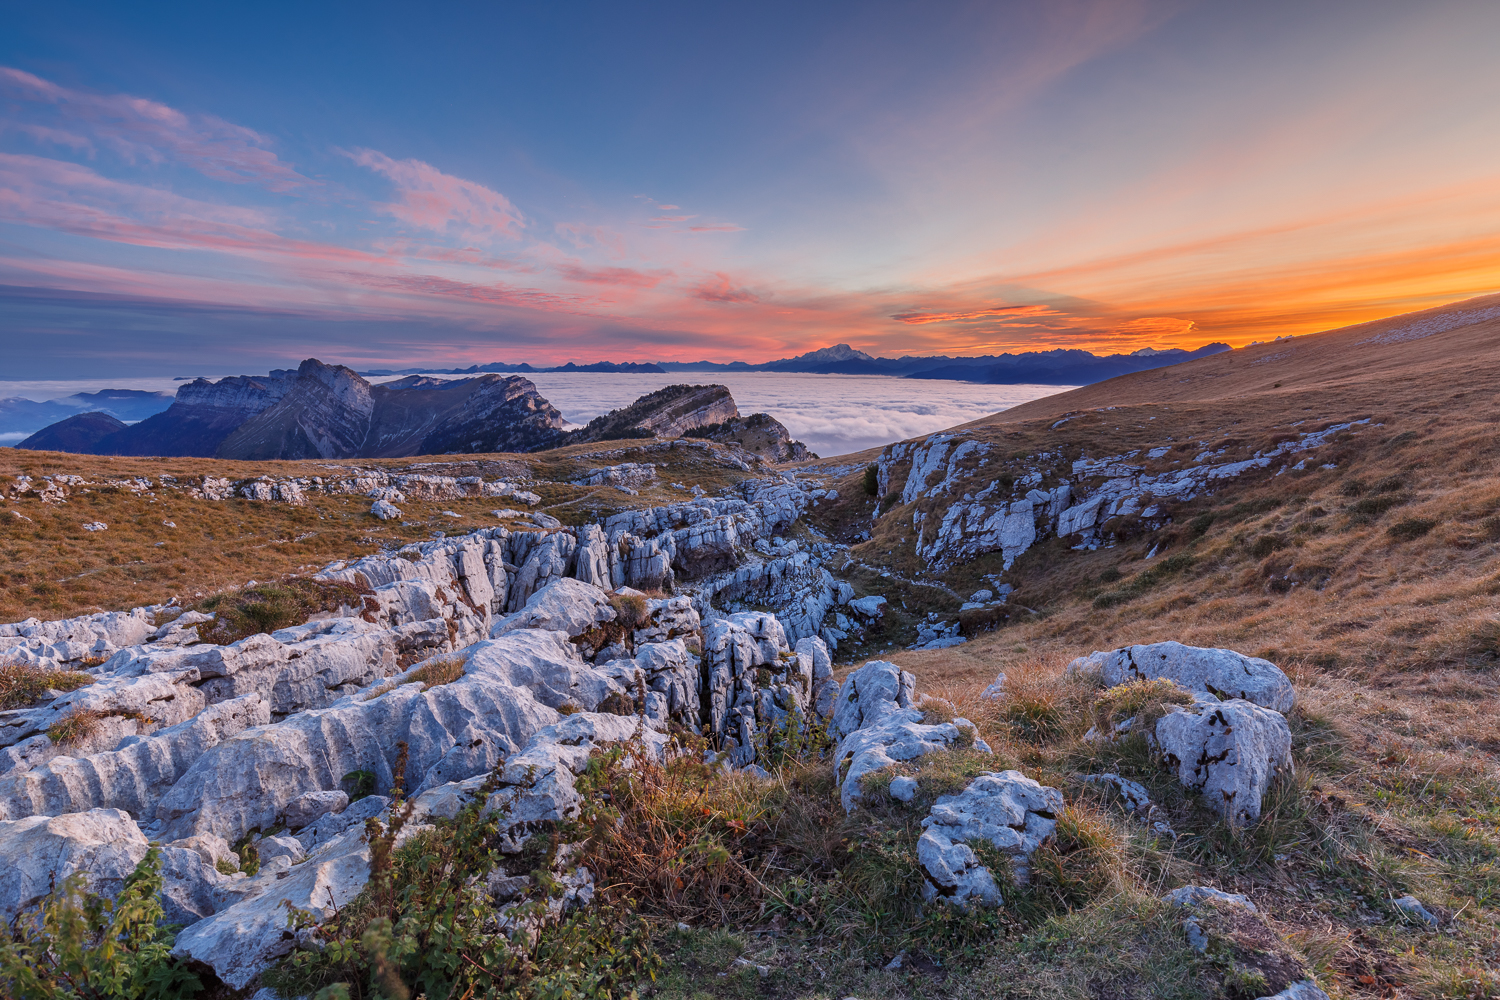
[0,66,312,192]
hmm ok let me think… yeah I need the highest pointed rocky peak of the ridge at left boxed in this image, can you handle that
[218,358,375,459]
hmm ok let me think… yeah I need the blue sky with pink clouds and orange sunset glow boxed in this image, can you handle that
[0,0,1500,379]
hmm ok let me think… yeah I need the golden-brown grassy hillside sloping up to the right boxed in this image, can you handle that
[720,301,1500,997]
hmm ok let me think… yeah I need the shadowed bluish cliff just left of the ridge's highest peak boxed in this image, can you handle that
[91,369,297,459]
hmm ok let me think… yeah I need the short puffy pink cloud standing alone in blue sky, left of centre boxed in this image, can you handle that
[348,150,525,238]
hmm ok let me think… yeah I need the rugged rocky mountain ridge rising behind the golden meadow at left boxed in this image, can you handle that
[17,358,807,460]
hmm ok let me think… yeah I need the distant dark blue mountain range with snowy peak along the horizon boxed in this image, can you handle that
[362,343,1230,385]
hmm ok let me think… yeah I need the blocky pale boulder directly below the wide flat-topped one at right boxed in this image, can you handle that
[1154,699,1292,826]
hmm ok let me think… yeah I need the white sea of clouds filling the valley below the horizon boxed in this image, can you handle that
[0,372,1071,459]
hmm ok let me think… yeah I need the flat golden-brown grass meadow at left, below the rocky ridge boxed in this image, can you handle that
[0,441,746,621]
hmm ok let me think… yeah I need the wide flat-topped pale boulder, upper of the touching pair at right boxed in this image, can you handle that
[1068,642,1298,712]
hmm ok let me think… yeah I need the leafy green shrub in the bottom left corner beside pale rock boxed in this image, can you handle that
[0,847,203,1000]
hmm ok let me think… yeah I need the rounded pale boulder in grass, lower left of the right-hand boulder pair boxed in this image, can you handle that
[917,771,1062,906]
